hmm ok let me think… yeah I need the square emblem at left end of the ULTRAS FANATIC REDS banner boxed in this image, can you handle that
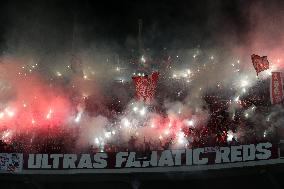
[0,153,23,172]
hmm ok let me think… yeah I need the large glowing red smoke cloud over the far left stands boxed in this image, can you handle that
[0,60,72,132]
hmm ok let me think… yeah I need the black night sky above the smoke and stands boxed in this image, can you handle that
[0,0,283,54]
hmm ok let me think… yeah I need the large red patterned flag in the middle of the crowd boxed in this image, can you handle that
[132,72,159,103]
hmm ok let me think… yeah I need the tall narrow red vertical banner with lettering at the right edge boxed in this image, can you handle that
[270,72,284,104]
